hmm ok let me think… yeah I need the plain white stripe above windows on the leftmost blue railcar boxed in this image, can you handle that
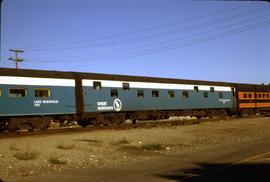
[0,76,75,87]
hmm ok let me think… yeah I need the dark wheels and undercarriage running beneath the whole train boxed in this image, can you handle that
[0,109,270,132]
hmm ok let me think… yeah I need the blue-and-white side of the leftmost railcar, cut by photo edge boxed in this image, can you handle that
[0,76,76,117]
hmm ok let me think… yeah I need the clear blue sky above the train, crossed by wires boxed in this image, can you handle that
[0,0,270,83]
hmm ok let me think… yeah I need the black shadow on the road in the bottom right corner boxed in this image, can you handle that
[158,162,270,182]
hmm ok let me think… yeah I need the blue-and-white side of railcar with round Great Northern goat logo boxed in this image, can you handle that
[82,79,235,112]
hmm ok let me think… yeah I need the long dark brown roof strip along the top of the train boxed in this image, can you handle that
[0,68,269,88]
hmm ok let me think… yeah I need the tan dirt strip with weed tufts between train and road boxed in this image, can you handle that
[0,117,270,181]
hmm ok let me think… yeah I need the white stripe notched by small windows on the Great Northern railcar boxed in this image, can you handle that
[82,79,231,91]
